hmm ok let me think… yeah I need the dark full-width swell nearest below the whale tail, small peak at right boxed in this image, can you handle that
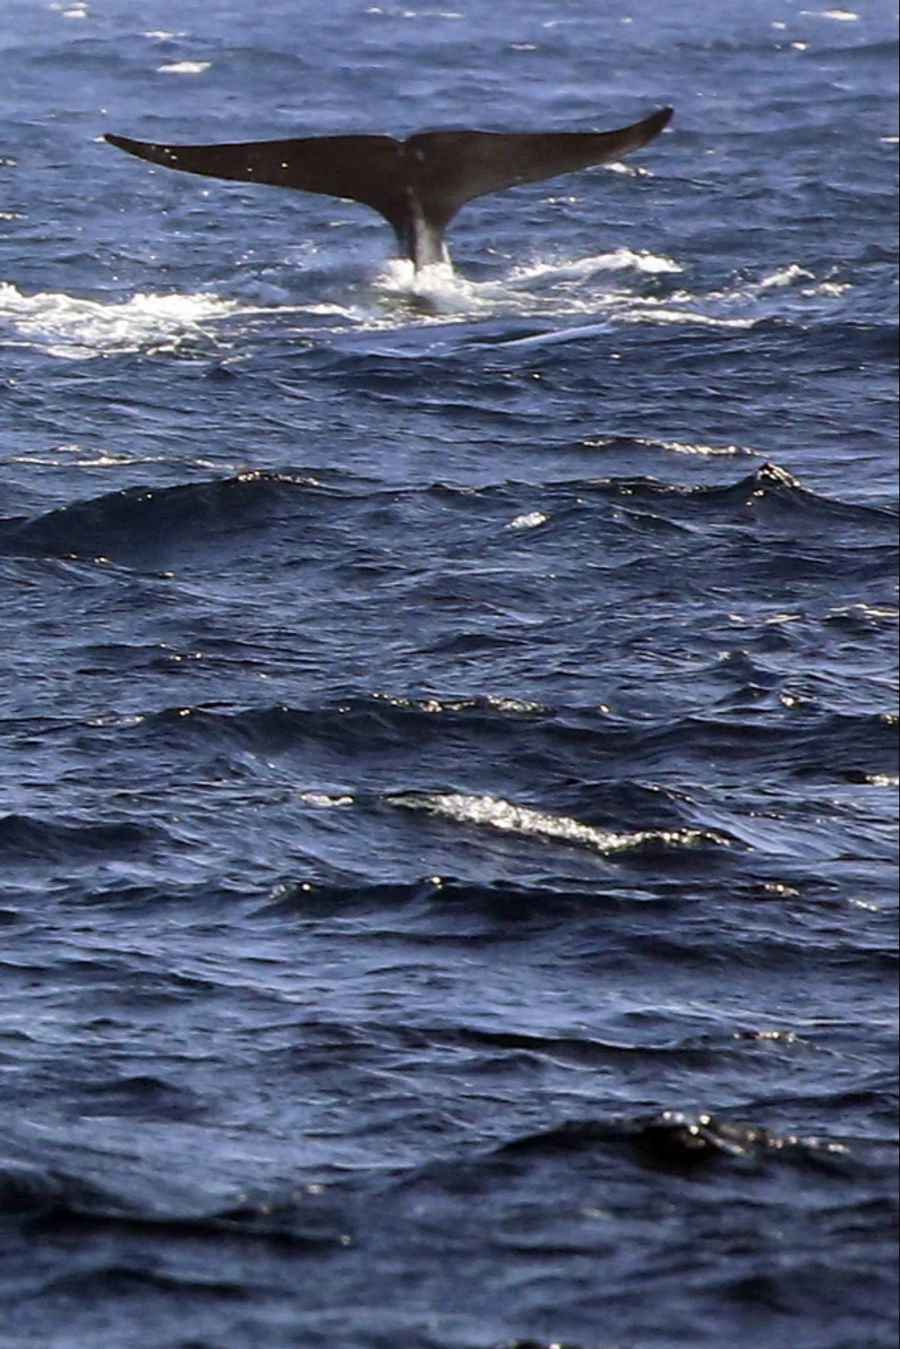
[0,461,897,557]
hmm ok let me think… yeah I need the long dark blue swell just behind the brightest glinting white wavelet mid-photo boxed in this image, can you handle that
[110,690,897,793]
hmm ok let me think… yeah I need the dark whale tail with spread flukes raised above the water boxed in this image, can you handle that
[104,108,672,267]
